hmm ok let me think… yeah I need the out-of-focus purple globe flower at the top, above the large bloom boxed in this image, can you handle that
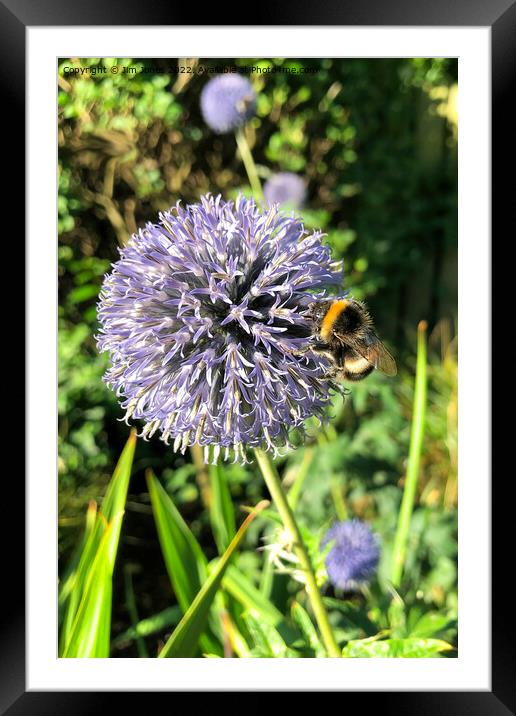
[201,74,256,134]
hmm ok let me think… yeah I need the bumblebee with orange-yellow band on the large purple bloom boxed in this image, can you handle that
[305,298,397,381]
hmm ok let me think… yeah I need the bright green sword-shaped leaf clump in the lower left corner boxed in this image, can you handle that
[59,430,136,658]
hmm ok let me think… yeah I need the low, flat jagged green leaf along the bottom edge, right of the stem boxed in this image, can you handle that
[342,637,453,659]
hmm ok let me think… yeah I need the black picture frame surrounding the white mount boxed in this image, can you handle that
[6,0,510,716]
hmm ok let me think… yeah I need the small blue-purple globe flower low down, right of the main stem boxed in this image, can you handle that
[321,519,380,591]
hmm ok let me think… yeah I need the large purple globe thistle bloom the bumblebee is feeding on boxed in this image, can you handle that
[97,195,342,461]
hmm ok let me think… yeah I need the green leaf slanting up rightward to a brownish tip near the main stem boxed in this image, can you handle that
[159,500,269,658]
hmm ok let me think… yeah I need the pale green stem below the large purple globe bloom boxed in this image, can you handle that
[254,448,341,657]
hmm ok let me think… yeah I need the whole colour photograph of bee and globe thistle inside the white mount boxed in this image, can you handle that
[57,56,463,668]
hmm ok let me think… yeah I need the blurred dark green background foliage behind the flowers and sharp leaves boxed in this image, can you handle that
[58,58,457,656]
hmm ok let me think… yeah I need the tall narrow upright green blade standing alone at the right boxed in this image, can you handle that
[391,321,426,588]
